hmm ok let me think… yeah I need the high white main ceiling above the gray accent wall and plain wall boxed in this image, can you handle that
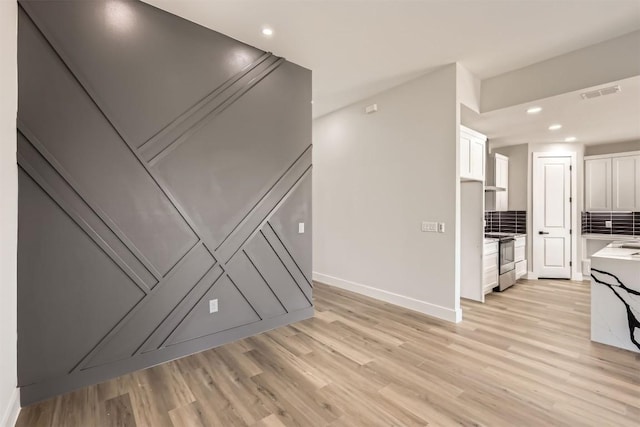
[146,0,640,117]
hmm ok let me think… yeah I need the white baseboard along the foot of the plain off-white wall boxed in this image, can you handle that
[313,271,462,323]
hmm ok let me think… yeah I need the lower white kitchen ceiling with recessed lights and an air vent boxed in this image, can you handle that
[461,77,640,150]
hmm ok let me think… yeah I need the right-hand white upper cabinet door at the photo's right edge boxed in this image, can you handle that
[611,156,640,211]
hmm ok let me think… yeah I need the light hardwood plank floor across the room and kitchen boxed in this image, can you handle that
[17,280,640,427]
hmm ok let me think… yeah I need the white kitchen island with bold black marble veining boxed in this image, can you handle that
[591,240,640,353]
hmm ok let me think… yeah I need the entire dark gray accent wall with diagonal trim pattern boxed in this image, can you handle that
[17,1,313,405]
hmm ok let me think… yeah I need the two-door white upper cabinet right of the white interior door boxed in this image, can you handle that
[584,152,640,211]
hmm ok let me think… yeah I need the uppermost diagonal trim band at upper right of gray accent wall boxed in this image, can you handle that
[146,57,284,166]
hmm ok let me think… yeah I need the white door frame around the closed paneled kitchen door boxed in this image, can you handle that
[527,151,582,281]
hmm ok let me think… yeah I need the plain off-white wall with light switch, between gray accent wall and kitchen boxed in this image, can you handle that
[313,64,460,321]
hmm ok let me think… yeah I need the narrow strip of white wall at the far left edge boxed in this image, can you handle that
[0,1,18,427]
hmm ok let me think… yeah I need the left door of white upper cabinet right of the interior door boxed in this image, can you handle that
[584,158,611,211]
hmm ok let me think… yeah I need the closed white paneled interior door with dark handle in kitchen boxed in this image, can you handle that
[532,157,571,279]
